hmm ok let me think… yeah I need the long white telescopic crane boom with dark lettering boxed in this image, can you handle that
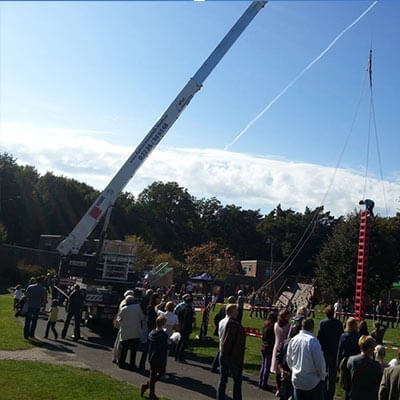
[57,1,267,256]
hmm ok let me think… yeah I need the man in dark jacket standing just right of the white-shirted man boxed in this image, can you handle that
[317,306,343,400]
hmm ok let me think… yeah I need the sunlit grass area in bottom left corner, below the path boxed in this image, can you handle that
[0,361,166,400]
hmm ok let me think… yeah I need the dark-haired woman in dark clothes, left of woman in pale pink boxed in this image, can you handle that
[258,312,278,389]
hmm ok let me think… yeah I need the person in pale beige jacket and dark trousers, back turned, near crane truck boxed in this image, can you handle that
[117,296,144,369]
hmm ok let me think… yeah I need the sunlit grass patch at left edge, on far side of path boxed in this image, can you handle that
[0,294,33,350]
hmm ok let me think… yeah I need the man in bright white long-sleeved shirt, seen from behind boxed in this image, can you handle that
[286,318,326,400]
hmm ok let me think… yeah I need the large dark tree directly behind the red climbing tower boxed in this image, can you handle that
[316,213,400,300]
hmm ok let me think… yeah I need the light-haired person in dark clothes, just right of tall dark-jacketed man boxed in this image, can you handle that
[337,317,360,400]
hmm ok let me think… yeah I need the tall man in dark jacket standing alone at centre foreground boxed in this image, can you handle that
[217,304,246,400]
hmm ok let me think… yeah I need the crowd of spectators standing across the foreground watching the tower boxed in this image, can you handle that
[14,277,400,400]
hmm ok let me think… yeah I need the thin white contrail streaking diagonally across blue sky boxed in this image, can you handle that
[225,1,378,150]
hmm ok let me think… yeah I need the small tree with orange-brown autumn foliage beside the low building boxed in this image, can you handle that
[185,242,239,279]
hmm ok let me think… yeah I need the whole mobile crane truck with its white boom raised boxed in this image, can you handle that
[57,1,267,324]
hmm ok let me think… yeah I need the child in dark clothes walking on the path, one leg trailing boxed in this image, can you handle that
[140,315,168,400]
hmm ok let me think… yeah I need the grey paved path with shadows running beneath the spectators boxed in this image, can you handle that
[0,310,275,400]
